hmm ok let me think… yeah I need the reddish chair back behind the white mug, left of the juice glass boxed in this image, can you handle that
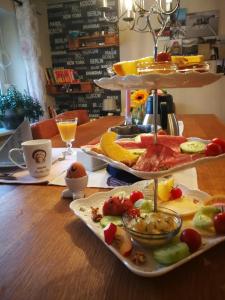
[31,119,59,139]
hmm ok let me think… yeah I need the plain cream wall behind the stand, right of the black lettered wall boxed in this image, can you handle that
[120,0,225,121]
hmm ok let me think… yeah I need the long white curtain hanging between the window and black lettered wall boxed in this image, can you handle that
[16,0,47,113]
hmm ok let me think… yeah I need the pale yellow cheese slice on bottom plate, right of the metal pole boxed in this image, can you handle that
[160,196,203,219]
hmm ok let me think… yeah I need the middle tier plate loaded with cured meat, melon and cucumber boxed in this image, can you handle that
[81,132,225,179]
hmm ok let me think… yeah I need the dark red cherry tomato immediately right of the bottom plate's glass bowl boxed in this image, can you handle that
[180,228,202,252]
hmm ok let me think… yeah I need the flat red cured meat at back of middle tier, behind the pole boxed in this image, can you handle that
[140,134,187,152]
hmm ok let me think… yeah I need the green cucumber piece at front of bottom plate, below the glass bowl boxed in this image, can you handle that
[153,242,190,265]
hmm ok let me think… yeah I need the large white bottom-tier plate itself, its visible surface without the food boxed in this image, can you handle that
[70,180,225,277]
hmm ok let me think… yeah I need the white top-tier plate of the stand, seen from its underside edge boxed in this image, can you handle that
[94,71,222,90]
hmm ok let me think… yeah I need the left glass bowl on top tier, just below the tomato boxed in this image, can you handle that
[137,61,177,75]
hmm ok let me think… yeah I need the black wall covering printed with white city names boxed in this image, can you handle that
[48,0,121,118]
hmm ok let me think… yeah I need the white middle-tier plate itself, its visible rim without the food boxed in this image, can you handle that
[81,137,225,179]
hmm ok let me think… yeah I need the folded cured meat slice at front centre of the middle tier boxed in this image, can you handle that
[133,144,192,172]
